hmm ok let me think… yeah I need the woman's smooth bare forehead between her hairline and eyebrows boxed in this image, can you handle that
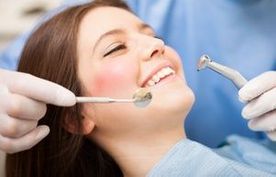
[76,7,147,52]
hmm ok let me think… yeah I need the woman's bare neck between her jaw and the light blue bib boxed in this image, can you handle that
[106,126,186,177]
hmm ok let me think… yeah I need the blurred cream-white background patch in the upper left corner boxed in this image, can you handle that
[0,0,62,51]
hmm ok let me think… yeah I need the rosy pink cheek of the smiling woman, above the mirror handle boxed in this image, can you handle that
[89,61,136,96]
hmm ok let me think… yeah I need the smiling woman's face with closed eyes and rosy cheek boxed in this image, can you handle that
[78,7,194,143]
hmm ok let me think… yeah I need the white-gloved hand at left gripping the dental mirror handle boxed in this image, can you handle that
[0,69,76,153]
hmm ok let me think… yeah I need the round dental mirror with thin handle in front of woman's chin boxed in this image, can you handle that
[76,88,152,107]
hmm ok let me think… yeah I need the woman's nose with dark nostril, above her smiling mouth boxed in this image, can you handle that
[140,37,165,60]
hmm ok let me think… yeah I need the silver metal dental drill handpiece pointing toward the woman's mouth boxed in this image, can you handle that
[197,55,247,89]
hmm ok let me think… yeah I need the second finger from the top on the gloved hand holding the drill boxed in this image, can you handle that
[242,88,276,119]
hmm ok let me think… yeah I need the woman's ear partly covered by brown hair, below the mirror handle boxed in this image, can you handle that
[64,111,95,135]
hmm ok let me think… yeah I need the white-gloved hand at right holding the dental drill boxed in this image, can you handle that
[239,71,276,141]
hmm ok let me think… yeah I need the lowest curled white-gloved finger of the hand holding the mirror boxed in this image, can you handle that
[0,125,50,154]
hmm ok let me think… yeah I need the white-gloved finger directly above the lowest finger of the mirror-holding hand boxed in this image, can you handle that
[0,114,37,138]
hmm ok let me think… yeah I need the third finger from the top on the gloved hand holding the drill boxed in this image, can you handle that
[248,111,276,131]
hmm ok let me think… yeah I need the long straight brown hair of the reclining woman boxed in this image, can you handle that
[6,0,129,177]
